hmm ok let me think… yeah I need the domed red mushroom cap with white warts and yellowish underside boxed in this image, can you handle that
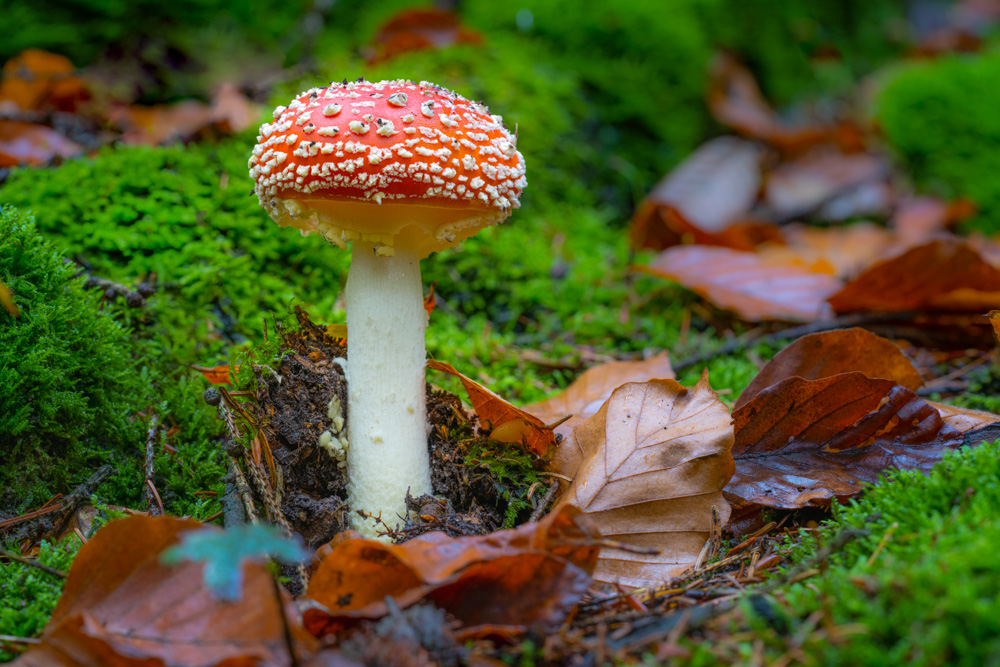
[249,80,527,256]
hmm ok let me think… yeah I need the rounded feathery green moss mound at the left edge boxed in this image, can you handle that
[0,207,143,507]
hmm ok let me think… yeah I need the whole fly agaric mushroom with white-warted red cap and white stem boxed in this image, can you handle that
[249,79,526,535]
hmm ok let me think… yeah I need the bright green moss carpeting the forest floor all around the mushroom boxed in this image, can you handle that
[0,0,1000,665]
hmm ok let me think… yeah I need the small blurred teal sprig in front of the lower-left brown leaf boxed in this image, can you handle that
[160,523,306,602]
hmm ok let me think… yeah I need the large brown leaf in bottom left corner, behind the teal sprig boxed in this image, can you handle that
[14,516,317,667]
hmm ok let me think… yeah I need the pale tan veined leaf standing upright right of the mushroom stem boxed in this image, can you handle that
[554,373,733,587]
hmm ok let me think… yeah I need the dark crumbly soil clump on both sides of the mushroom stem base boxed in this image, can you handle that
[237,309,508,549]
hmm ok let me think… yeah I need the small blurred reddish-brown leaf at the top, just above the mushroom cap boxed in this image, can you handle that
[368,7,483,64]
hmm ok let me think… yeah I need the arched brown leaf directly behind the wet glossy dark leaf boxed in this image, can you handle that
[733,328,924,410]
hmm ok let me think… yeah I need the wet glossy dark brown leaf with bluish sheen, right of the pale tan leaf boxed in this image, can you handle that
[726,372,962,509]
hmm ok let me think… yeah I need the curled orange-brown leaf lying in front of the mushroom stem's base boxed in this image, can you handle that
[304,506,599,636]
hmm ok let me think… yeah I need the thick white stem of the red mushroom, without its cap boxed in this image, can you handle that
[345,241,431,536]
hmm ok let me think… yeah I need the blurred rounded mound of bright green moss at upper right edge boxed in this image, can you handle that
[876,50,1000,232]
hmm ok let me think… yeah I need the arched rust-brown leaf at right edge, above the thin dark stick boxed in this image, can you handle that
[829,238,1000,313]
